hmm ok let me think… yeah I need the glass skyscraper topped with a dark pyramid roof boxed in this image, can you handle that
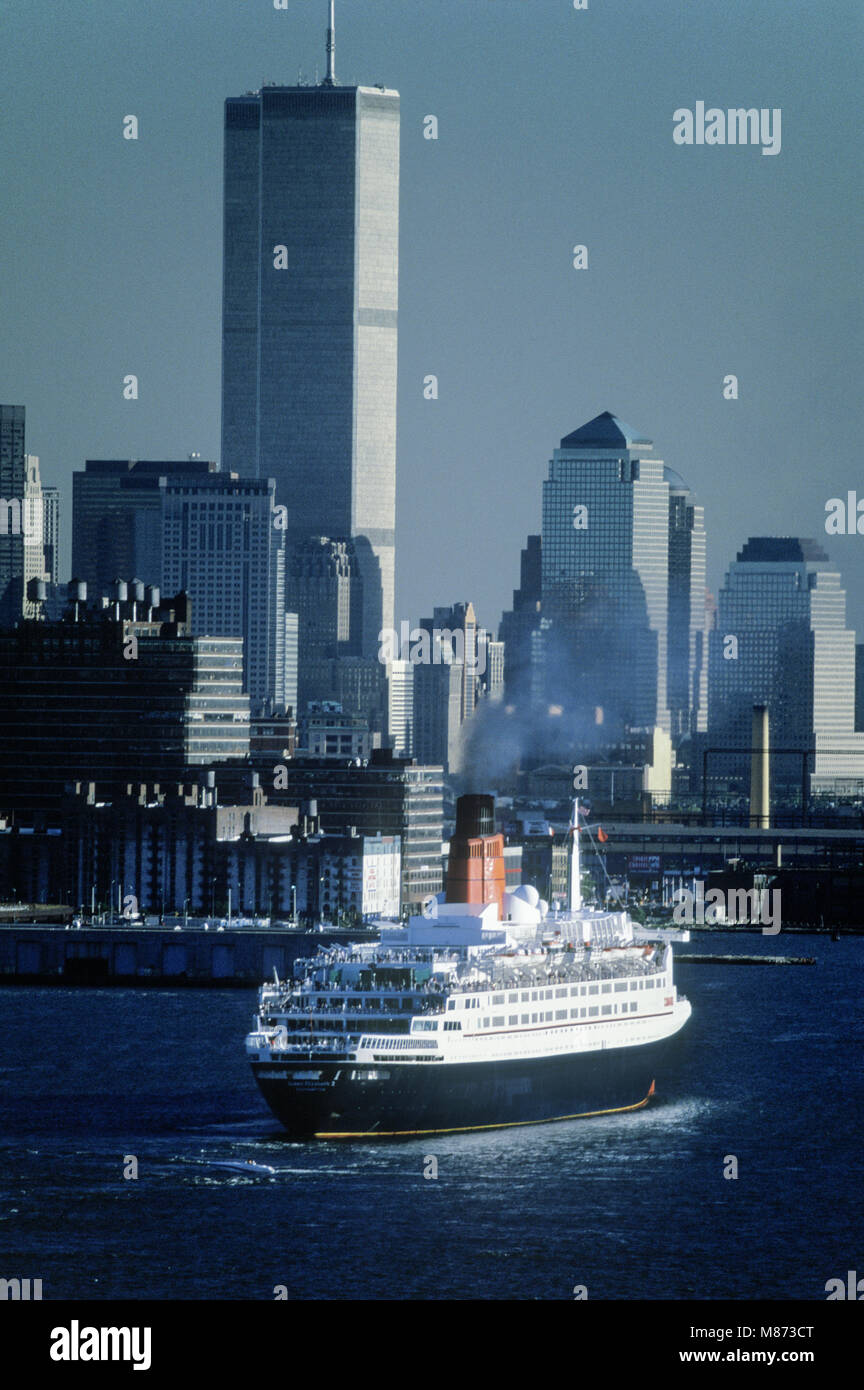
[533,410,670,742]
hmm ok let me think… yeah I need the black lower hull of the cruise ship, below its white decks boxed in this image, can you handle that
[253,1033,691,1138]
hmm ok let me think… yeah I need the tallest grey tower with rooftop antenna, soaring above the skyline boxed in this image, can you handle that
[222,4,399,656]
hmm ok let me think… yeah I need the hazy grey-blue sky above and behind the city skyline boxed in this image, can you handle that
[0,0,864,632]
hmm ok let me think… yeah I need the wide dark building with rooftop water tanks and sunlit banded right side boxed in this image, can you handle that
[0,581,249,810]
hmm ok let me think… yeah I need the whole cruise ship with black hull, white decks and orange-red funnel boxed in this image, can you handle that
[246,795,690,1140]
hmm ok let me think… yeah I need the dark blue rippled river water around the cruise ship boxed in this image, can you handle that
[0,934,864,1300]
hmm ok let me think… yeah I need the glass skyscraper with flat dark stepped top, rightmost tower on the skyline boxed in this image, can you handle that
[708,537,864,795]
